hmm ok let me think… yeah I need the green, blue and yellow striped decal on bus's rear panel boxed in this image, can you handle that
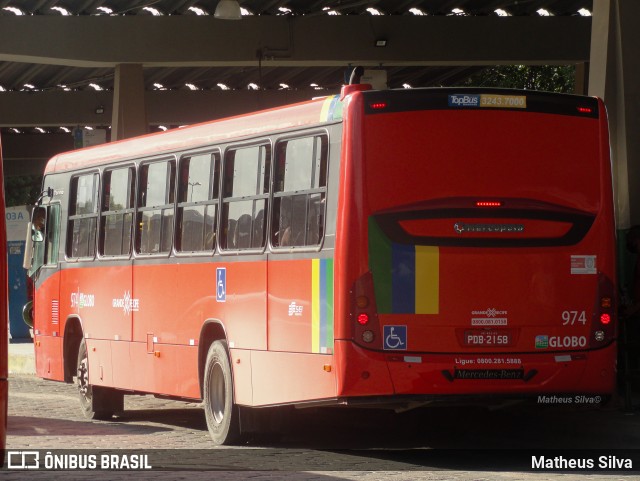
[369,217,440,314]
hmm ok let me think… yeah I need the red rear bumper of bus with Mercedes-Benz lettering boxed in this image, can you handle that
[336,341,616,397]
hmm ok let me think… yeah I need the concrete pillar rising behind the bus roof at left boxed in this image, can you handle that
[111,63,149,141]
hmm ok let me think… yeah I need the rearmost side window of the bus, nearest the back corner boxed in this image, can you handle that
[271,135,328,248]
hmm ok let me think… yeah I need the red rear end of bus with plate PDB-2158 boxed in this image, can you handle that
[336,90,616,398]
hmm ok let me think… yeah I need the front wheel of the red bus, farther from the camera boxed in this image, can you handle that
[76,338,124,420]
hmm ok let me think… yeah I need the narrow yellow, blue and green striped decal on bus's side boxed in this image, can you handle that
[311,259,333,354]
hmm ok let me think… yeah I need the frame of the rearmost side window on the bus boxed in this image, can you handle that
[267,129,331,255]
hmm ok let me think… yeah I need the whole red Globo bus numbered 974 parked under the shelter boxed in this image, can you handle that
[23,85,616,443]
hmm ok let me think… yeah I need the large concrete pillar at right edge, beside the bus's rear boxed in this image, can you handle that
[589,0,640,232]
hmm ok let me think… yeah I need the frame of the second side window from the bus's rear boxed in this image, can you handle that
[216,137,274,256]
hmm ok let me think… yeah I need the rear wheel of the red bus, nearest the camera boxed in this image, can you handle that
[203,341,240,445]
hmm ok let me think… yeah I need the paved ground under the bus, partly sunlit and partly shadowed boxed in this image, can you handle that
[0,340,640,481]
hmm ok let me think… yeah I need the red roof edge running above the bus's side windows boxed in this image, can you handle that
[45,96,340,174]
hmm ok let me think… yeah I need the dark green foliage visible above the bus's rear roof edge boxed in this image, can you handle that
[462,65,575,93]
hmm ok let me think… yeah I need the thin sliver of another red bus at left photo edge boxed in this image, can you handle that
[0,134,9,458]
